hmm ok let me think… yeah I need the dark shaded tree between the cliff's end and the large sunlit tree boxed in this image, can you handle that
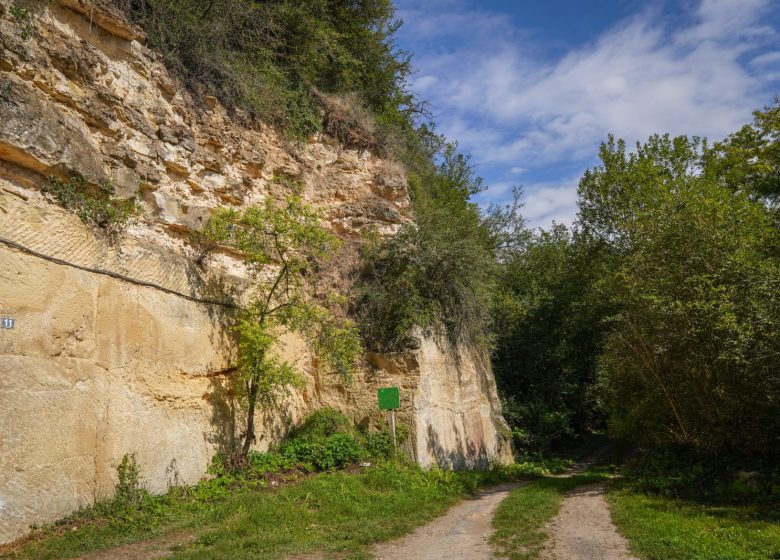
[492,225,608,454]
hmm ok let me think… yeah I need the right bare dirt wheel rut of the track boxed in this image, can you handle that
[541,483,637,560]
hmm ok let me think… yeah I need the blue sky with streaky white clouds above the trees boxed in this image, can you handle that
[395,0,780,227]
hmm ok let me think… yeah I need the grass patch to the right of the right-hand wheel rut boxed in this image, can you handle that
[607,487,780,560]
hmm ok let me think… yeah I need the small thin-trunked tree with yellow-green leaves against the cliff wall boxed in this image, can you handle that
[203,193,362,456]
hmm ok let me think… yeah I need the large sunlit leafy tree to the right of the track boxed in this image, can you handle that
[579,136,780,451]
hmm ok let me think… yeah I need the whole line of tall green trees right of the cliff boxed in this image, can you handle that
[494,102,780,453]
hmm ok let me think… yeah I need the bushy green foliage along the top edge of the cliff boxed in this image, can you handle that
[111,0,413,142]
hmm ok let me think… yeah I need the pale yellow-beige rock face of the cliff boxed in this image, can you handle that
[0,0,511,543]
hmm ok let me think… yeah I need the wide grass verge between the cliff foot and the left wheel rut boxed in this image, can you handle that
[0,462,560,560]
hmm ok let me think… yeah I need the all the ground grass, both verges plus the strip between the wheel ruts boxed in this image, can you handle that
[13,438,780,560]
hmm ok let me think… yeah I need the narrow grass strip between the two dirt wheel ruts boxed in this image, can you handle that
[491,470,608,560]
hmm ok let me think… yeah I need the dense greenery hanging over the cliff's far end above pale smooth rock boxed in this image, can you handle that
[355,140,495,351]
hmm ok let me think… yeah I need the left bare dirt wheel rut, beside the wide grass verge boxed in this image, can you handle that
[374,484,518,560]
